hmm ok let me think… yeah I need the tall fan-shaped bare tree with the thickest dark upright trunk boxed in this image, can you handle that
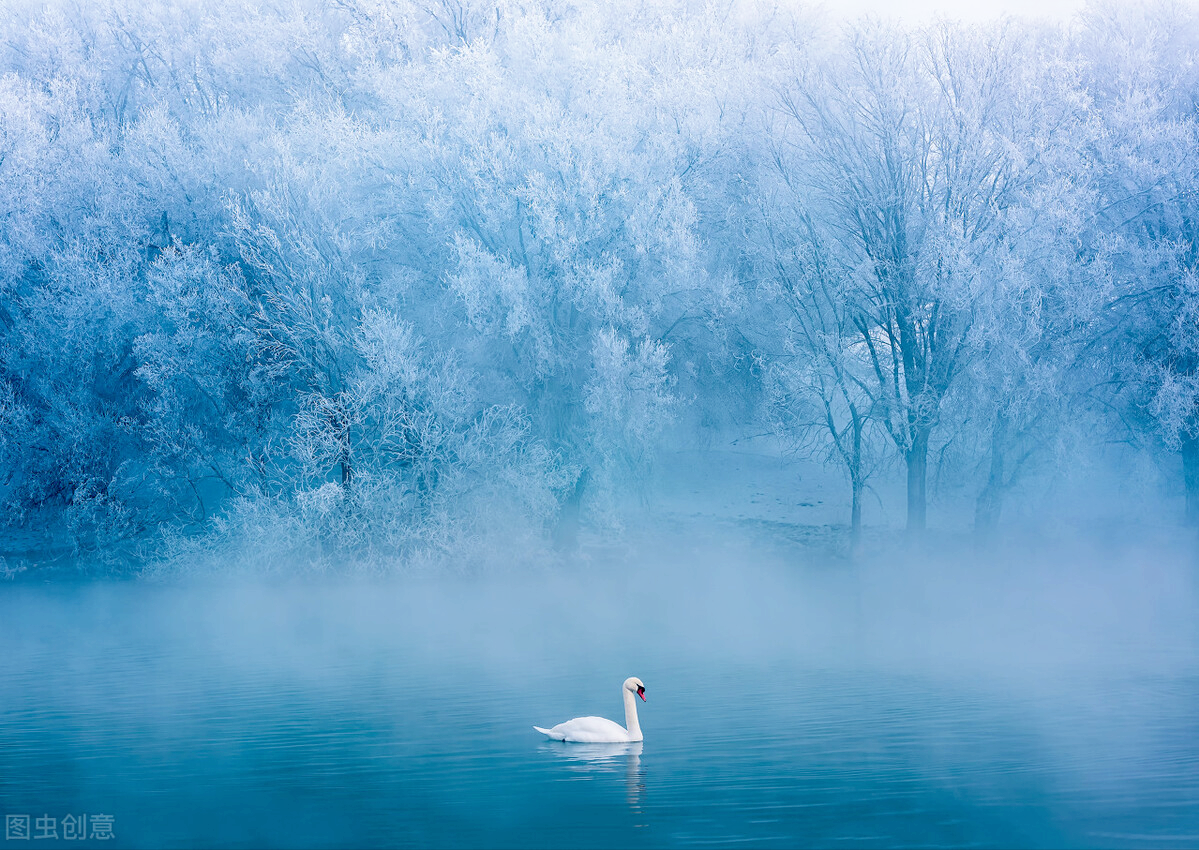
[757,24,1050,531]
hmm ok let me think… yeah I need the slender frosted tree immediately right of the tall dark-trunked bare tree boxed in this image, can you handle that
[952,30,1104,537]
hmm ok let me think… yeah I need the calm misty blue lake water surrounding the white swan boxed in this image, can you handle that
[0,556,1199,848]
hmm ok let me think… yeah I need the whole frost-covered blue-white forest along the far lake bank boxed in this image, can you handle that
[0,0,1199,571]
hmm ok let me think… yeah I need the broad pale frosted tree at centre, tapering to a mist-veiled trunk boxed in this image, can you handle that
[381,4,733,538]
